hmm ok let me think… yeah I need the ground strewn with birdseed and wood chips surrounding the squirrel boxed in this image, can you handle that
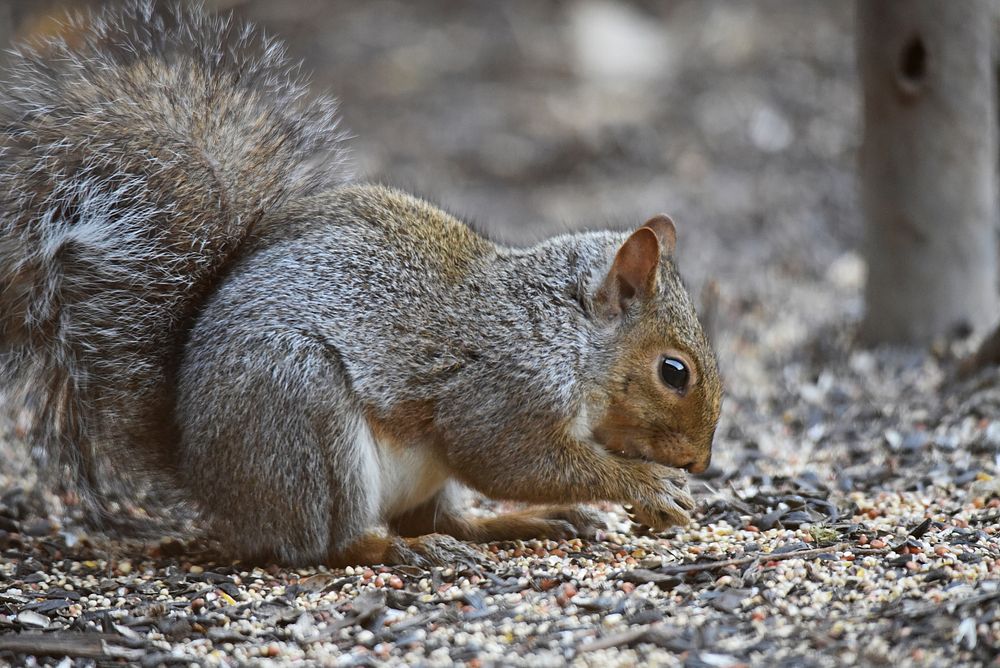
[0,0,1000,667]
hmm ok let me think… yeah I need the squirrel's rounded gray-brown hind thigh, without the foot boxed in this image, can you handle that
[177,332,381,565]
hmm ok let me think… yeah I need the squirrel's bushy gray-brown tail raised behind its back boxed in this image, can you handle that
[0,0,345,528]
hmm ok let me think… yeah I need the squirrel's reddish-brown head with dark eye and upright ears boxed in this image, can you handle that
[591,215,722,473]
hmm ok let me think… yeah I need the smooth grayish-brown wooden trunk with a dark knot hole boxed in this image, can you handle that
[856,0,1000,343]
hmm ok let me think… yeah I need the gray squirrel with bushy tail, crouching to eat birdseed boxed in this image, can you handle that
[0,0,722,566]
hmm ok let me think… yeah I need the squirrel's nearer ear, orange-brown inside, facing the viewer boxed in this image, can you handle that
[594,224,661,320]
